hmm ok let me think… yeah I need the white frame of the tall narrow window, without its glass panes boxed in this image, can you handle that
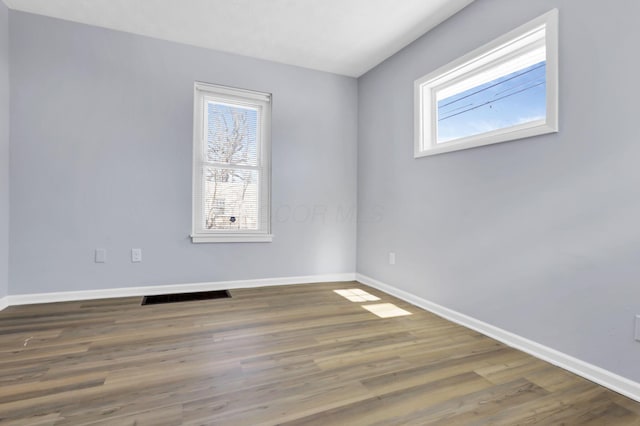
[191,82,273,243]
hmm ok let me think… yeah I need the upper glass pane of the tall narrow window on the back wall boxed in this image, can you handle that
[210,101,258,166]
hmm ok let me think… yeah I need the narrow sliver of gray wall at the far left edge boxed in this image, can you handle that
[0,1,9,298]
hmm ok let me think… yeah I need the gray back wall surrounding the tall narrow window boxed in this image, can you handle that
[9,12,357,294]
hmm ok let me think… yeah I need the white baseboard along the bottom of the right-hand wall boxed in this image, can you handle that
[356,274,640,401]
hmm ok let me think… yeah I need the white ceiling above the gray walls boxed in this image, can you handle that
[4,0,473,77]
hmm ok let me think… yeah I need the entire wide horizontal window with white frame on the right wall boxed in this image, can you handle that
[414,9,558,158]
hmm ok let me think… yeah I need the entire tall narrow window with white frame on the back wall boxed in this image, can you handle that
[191,82,273,243]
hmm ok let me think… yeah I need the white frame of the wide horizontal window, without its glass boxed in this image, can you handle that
[414,9,558,158]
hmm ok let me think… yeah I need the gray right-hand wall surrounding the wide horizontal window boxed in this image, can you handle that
[357,0,640,381]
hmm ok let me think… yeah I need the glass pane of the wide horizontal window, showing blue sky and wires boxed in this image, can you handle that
[436,59,547,143]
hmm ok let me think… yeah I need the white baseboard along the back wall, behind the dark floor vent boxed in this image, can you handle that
[0,273,356,310]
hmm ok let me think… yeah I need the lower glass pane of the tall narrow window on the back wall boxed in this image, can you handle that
[203,167,259,230]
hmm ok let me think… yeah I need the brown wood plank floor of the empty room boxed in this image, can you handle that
[0,282,640,426]
